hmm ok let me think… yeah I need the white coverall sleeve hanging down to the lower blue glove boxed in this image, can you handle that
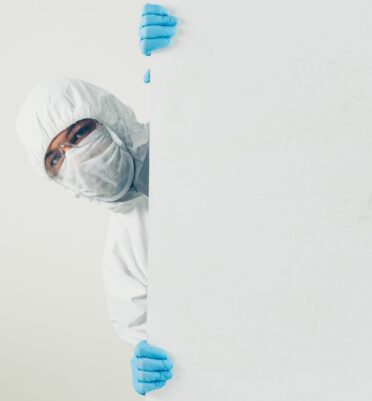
[102,196,148,347]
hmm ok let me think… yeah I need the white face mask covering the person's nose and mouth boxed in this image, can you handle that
[55,125,134,201]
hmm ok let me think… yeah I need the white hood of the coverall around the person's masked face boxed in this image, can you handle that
[16,77,149,210]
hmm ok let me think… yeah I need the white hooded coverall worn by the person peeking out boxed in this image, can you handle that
[16,77,149,347]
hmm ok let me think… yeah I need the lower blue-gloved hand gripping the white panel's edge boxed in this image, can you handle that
[131,340,173,395]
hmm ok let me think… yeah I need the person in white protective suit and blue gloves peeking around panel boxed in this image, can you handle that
[16,4,177,395]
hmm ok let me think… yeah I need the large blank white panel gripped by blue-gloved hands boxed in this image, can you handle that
[148,0,372,401]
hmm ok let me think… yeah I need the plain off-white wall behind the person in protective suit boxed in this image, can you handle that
[0,0,148,401]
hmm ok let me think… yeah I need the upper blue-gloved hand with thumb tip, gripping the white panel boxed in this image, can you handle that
[138,4,177,83]
